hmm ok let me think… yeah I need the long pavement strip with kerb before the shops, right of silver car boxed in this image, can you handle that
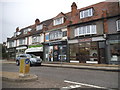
[42,62,120,72]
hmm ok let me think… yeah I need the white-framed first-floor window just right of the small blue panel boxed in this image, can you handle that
[49,30,63,40]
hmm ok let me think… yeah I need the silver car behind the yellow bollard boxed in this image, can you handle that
[16,54,42,66]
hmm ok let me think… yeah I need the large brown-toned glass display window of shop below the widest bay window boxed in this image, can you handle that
[70,42,98,63]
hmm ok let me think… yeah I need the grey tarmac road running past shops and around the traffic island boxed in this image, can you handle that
[2,64,118,89]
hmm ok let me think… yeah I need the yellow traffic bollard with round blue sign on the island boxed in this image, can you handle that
[19,58,30,77]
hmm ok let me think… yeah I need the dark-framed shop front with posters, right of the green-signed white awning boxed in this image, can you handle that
[44,41,67,62]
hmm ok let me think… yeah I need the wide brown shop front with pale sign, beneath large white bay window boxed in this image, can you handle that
[68,37,106,64]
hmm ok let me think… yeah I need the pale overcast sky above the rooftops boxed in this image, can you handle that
[0,0,108,43]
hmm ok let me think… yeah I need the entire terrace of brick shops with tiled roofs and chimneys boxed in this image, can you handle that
[7,2,120,64]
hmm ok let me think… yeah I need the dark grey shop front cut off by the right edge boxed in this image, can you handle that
[107,35,120,64]
